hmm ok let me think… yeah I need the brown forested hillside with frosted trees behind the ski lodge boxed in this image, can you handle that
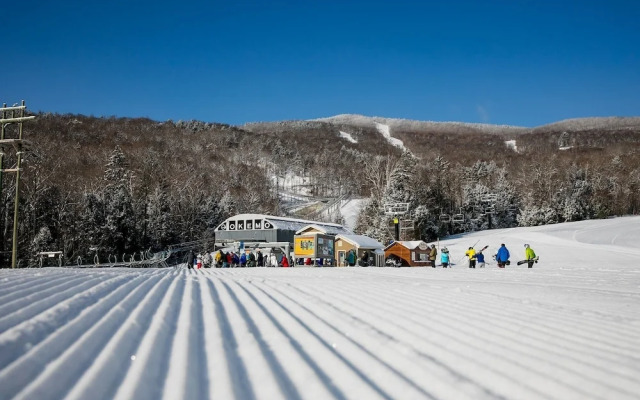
[0,114,640,266]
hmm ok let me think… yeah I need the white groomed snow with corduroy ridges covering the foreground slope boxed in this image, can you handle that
[0,217,640,399]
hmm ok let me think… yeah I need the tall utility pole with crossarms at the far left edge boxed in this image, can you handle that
[0,100,35,268]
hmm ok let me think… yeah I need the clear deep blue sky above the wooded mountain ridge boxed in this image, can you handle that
[0,0,640,126]
